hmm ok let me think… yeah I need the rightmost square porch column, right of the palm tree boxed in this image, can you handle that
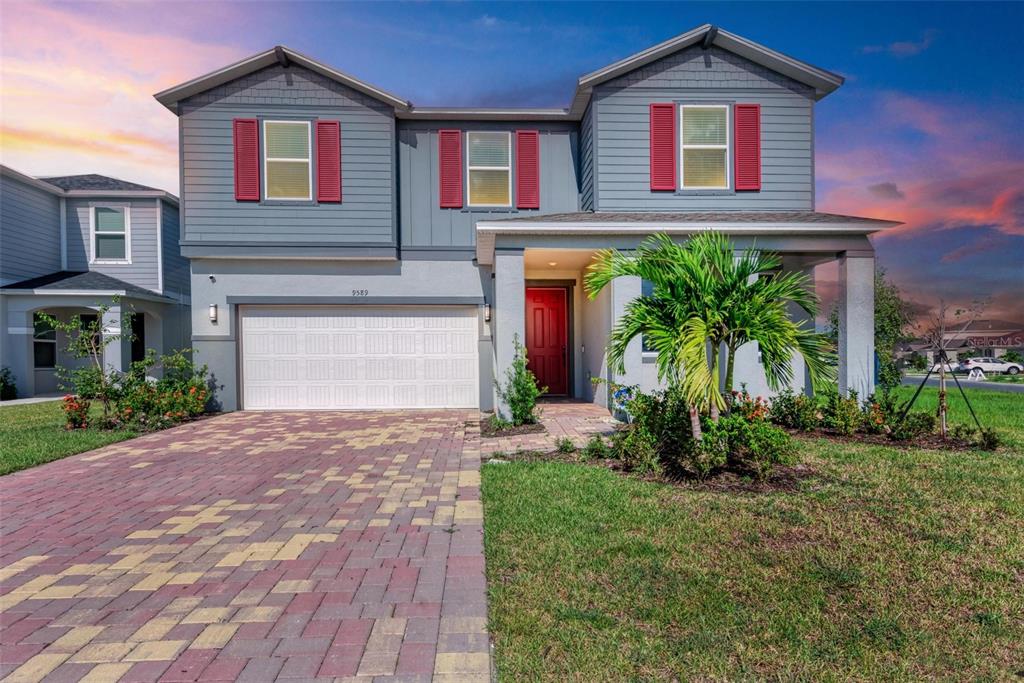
[839,252,874,398]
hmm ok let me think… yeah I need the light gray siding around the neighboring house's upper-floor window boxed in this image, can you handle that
[67,198,160,291]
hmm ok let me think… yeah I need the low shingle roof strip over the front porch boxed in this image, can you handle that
[487,211,897,225]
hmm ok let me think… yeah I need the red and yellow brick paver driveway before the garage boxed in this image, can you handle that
[0,412,488,681]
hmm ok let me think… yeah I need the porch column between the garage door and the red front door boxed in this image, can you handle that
[492,249,526,419]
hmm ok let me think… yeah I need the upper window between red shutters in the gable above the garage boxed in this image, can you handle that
[263,121,313,201]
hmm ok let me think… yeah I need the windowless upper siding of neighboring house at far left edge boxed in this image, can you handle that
[0,174,60,285]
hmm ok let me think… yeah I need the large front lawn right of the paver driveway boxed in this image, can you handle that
[482,391,1024,681]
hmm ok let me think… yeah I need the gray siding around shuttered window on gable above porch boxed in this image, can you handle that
[592,46,814,211]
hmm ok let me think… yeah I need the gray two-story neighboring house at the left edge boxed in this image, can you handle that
[0,166,191,397]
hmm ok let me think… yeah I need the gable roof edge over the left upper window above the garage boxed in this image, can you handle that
[154,45,412,113]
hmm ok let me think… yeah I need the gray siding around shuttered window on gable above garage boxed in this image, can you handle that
[179,65,395,247]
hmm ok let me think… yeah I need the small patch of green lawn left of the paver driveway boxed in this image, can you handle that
[0,400,137,475]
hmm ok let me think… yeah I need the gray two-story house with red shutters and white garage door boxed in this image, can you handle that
[156,26,896,410]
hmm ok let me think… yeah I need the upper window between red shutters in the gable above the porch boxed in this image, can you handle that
[679,104,731,189]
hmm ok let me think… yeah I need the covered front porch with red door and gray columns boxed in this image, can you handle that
[477,212,896,417]
